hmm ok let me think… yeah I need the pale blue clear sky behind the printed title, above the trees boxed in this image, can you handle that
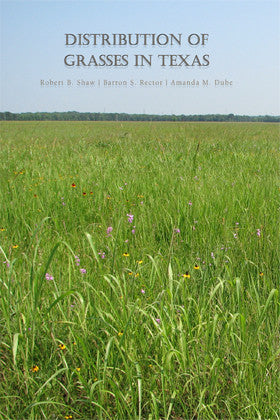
[0,0,280,115]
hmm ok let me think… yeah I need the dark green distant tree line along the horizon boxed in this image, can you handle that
[0,111,280,122]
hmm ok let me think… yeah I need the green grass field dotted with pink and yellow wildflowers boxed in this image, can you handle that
[0,122,280,420]
